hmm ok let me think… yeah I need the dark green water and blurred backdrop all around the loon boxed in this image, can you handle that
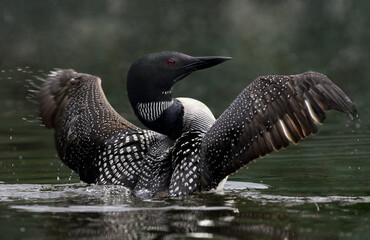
[0,1,370,239]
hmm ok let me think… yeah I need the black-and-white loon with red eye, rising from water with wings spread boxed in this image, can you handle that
[38,52,356,197]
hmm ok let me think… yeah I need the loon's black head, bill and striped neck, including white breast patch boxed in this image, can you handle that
[127,52,230,139]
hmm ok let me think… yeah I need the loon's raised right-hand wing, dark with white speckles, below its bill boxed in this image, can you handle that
[201,72,356,190]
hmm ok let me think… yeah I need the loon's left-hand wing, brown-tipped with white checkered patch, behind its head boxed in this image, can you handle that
[39,70,169,188]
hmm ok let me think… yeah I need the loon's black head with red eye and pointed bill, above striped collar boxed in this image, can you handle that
[127,52,231,104]
